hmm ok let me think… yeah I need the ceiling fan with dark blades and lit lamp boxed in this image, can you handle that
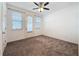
[33,2,50,12]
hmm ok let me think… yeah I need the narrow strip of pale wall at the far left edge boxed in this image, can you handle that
[0,2,2,56]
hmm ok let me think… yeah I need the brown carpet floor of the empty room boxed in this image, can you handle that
[3,35,78,56]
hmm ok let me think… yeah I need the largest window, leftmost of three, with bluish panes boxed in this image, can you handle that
[11,11,22,30]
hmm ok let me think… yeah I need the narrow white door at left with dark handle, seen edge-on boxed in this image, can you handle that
[2,2,7,52]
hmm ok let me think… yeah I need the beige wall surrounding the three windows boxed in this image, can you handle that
[7,5,41,42]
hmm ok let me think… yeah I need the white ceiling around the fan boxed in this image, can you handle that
[8,2,76,16]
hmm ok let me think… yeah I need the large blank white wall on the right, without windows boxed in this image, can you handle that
[43,4,78,44]
